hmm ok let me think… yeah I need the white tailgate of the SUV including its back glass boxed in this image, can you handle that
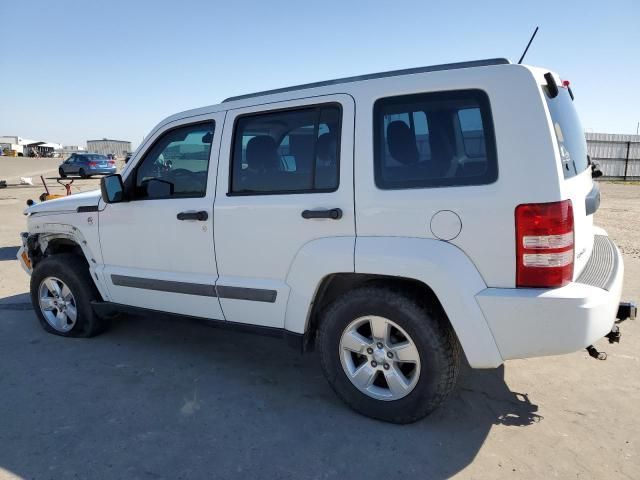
[545,84,600,279]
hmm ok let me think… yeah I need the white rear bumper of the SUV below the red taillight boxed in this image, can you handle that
[476,232,624,360]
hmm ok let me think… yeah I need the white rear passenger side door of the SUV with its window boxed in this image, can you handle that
[214,95,355,328]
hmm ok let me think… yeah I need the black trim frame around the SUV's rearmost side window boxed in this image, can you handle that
[372,88,500,191]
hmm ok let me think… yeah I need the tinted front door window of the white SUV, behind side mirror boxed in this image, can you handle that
[134,122,214,200]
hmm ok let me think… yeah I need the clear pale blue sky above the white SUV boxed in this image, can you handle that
[0,0,640,147]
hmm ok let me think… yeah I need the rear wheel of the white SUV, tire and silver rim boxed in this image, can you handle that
[317,286,460,423]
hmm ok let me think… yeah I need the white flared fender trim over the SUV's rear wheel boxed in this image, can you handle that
[285,237,503,368]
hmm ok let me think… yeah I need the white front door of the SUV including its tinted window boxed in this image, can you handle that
[98,113,224,320]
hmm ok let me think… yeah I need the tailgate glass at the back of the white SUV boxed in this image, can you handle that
[545,88,589,178]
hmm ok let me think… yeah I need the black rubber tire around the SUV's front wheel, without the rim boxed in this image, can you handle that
[30,253,108,337]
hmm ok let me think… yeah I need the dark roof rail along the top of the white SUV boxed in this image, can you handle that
[222,58,511,103]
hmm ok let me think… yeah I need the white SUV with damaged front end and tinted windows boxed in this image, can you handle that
[18,59,629,423]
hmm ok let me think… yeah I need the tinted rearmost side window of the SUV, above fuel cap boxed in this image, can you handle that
[374,90,498,189]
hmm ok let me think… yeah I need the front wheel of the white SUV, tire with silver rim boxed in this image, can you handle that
[30,253,107,337]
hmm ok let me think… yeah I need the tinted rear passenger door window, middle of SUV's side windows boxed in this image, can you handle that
[230,105,341,195]
